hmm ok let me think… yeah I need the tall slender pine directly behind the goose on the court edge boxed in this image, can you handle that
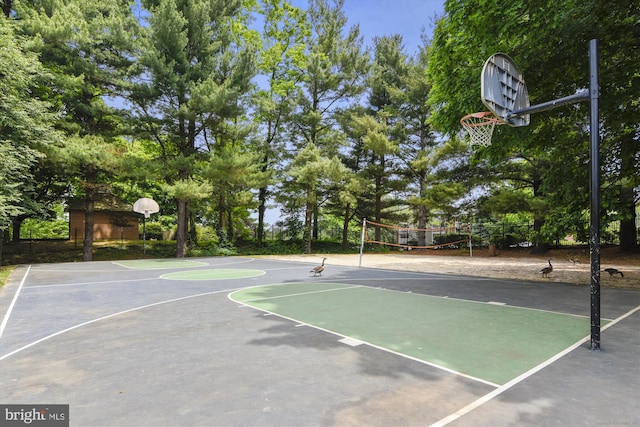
[285,0,368,252]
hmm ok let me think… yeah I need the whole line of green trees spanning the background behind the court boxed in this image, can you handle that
[0,0,640,260]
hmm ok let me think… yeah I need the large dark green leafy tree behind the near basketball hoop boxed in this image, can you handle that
[429,0,640,246]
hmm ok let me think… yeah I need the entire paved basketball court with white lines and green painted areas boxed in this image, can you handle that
[0,257,640,426]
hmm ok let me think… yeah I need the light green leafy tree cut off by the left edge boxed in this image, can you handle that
[0,15,58,259]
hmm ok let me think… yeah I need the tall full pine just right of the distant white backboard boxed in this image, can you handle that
[129,0,255,257]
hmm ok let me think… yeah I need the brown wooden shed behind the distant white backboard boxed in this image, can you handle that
[68,199,140,240]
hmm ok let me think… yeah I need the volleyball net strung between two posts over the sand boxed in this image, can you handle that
[360,222,472,266]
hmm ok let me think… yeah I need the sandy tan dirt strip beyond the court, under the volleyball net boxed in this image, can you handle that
[261,249,640,290]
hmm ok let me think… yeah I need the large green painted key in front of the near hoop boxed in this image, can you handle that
[230,283,607,385]
